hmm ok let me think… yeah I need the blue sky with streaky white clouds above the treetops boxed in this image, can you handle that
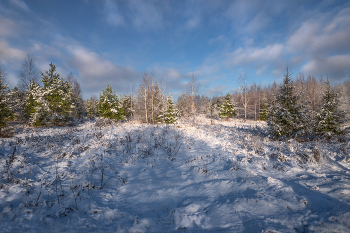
[0,0,350,100]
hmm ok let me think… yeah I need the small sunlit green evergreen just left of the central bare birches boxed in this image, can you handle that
[98,84,125,120]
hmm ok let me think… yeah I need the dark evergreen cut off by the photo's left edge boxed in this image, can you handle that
[0,69,13,135]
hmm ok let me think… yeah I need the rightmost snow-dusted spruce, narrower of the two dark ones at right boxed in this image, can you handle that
[316,78,345,138]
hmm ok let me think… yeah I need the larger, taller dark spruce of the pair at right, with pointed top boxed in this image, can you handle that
[267,68,307,138]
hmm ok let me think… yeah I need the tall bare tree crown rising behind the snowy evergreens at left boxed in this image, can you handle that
[17,54,39,91]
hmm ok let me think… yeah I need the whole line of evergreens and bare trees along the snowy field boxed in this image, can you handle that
[0,55,350,137]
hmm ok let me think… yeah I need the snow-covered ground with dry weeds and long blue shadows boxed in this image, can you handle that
[0,118,350,232]
